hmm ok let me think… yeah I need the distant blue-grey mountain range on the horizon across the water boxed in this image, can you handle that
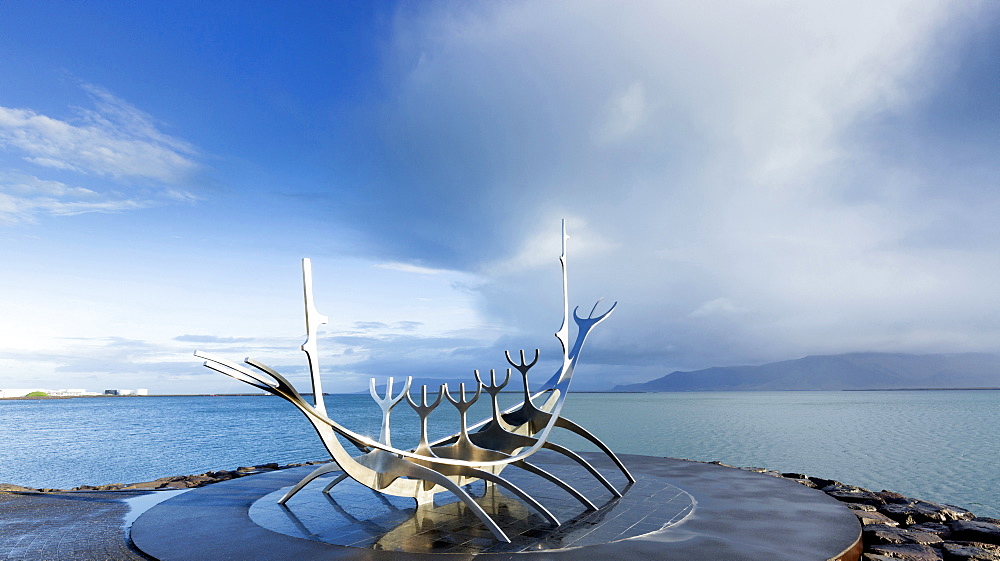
[613,353,1000,392]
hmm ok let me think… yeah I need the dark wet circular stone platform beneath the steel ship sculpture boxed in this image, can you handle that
[131,451,861,561]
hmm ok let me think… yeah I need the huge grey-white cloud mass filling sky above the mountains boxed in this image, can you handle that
[368,1,1000,380]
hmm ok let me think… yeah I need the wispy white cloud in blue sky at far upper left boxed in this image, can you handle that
[0,85,199,223]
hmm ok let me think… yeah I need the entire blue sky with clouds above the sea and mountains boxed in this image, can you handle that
[0,0,1000,394]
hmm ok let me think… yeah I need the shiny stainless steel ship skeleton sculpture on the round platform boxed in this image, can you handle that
[195,222,635,542]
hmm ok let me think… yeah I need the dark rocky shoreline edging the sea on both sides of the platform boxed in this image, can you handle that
[0,462,1000,561]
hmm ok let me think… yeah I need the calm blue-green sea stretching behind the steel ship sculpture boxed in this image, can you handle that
[0,391,1000,518]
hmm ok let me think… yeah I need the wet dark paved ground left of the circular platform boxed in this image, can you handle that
[0,491,149,561]
